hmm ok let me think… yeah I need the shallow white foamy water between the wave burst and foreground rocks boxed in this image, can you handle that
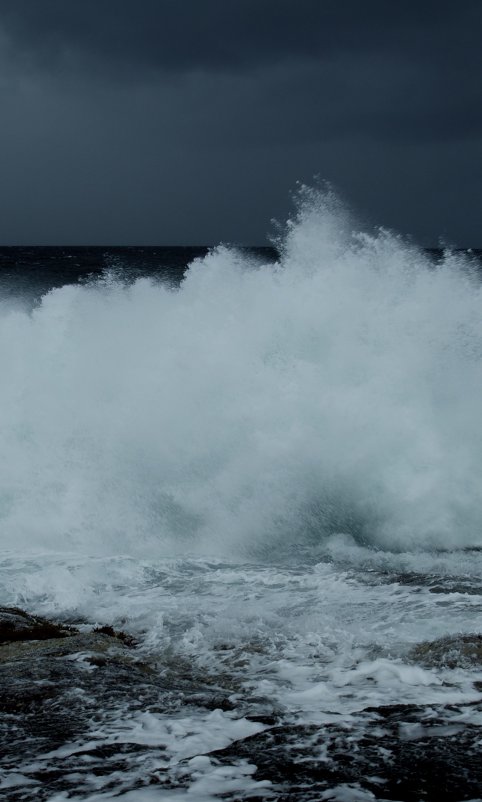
[0,537,482,800]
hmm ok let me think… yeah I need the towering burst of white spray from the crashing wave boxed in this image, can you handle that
[0,189,482,557]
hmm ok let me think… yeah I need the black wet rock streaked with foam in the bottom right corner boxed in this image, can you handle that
[213,705,482,802]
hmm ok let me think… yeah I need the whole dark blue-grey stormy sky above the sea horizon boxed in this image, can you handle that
[0,0,482,246]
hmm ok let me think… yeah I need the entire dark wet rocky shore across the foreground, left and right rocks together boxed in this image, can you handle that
[0,607,482,802]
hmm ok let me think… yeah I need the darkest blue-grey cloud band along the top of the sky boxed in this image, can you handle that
[0,0,482,75]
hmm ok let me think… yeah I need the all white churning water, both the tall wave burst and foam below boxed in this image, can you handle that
[0,189,482,802]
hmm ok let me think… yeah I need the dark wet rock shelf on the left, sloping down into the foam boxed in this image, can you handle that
[0,608,243,802]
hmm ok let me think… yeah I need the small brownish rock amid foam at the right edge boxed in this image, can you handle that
[409,634,482,668]
